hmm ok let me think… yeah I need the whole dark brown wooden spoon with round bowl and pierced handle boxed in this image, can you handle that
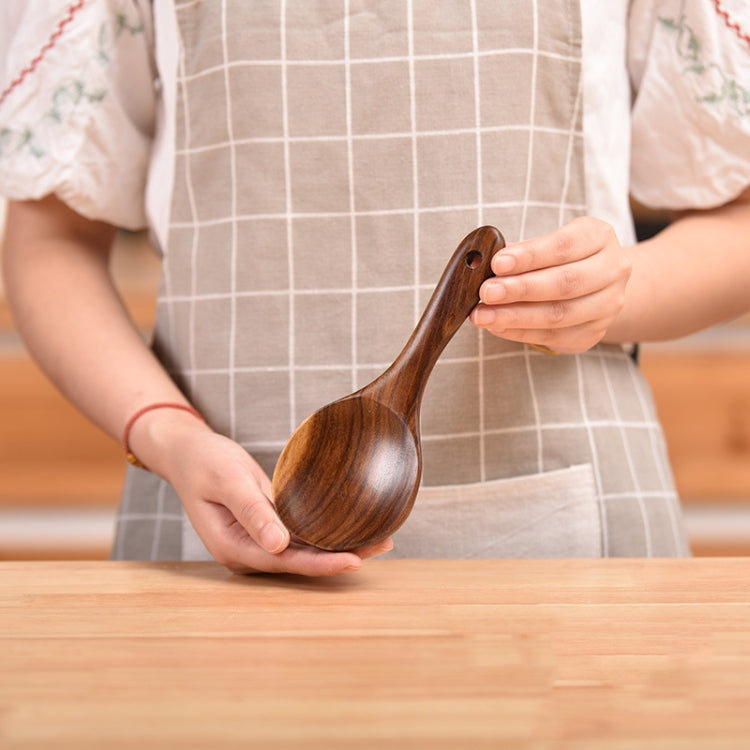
[273,227,505,550]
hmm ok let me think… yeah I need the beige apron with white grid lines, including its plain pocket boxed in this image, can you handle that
[114,0,688,559]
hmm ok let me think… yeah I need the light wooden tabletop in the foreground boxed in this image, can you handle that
[0,558,750,750]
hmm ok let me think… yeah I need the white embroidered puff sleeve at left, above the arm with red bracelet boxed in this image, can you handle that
[0,0,157,229]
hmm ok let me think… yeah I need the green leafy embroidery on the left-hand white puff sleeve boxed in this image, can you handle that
[0,8,144,160]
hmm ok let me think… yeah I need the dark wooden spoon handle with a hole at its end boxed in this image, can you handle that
[363,226,505,429]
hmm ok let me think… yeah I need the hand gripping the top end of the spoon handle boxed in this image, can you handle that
[471,217,632,354]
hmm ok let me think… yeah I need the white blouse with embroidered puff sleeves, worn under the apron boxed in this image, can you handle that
[0,0,750,253]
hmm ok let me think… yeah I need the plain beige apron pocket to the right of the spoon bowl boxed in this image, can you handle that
[382,464,602,558]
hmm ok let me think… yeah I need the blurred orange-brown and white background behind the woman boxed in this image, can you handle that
[0,203,750,560]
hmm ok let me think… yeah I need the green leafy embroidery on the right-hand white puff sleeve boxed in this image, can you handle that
[659,0,750,118]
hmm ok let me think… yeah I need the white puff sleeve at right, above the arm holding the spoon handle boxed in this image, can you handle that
[628,0,750,210]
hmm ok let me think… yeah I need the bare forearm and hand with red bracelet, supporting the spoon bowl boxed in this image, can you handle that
[2,195,391,576]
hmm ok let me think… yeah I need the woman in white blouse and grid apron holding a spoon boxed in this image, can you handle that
[0,0,750,575]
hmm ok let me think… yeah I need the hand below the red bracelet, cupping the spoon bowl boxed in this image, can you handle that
[131,409,393,576]
